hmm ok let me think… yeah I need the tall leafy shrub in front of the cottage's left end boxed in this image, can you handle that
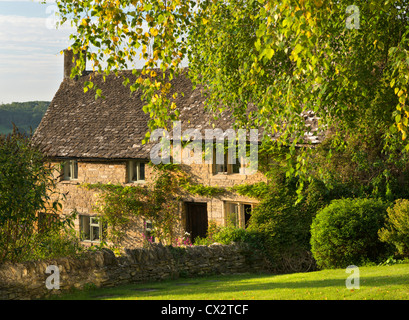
[0,130,77,262]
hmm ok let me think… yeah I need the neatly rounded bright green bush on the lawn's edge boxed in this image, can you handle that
[311,199,391,268]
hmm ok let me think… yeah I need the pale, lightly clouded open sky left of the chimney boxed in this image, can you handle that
[0,0,74,104]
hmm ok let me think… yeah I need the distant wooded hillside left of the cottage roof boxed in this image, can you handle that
[0,101,50,134]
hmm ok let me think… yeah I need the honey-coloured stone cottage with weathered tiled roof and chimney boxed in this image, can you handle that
[33,51,322,246]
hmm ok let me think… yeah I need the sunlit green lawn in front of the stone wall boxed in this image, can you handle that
[48,264,409,300]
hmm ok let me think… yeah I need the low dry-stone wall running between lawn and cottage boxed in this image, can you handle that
[0,244,269,300]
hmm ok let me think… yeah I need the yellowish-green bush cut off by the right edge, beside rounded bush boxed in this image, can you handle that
[379,199,409,257]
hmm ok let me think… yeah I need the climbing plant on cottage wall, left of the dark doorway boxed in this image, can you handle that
[83,166,179,246]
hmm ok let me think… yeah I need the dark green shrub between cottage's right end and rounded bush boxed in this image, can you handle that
[244,178,328,273]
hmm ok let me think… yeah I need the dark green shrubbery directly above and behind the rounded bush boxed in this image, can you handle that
[310,121,409,201]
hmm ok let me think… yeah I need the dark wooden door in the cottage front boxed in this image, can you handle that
[186,202,208,243]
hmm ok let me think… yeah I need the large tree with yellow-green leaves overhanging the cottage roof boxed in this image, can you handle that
[53,0,409,178]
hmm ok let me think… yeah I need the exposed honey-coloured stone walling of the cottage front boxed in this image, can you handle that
[53,160,267,247]
